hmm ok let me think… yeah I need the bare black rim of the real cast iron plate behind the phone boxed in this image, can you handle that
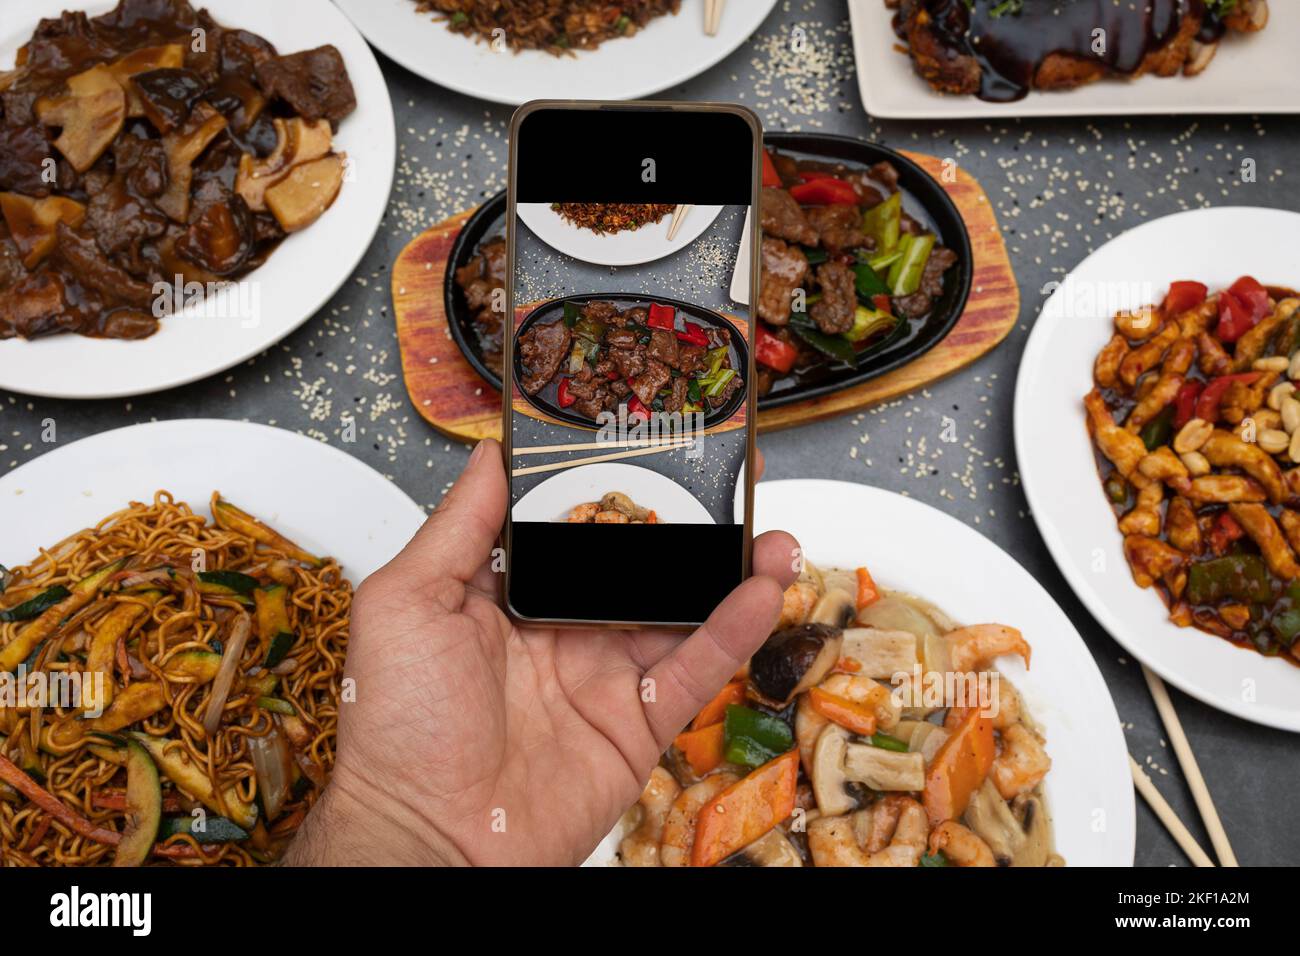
[443,133,974,410]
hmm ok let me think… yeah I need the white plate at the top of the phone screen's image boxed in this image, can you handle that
[515,203,723,265]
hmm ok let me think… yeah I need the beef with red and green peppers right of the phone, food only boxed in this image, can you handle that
[754,150,957,394]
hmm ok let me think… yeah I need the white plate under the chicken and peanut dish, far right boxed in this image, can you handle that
[1015,209,1300,731]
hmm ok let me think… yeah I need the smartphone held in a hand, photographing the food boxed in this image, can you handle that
[502,101,762,628]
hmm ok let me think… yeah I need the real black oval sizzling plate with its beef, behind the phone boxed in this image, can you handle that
[443,133,974,408]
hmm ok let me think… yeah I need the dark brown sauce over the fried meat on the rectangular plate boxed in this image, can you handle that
[909,0,1222,103]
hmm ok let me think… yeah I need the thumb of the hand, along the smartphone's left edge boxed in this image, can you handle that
[391,438,508,583]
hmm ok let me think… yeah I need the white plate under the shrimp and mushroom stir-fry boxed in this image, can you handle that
[588,480,1136,866]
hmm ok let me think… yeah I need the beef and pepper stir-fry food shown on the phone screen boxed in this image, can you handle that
[519,300,745,420]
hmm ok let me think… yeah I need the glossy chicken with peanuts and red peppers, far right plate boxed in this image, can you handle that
[1084,276,1300,662]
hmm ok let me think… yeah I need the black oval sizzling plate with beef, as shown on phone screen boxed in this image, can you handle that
[514,293,749,428]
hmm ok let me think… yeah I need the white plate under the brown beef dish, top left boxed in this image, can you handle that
[0,0,397,398]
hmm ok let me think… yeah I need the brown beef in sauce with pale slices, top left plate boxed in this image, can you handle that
[0,0,356,338]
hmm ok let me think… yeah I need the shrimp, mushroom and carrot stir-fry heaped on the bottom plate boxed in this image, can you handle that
[619,564,1063,866]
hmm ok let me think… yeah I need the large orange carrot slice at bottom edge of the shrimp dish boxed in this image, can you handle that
[690,750,800,866]
